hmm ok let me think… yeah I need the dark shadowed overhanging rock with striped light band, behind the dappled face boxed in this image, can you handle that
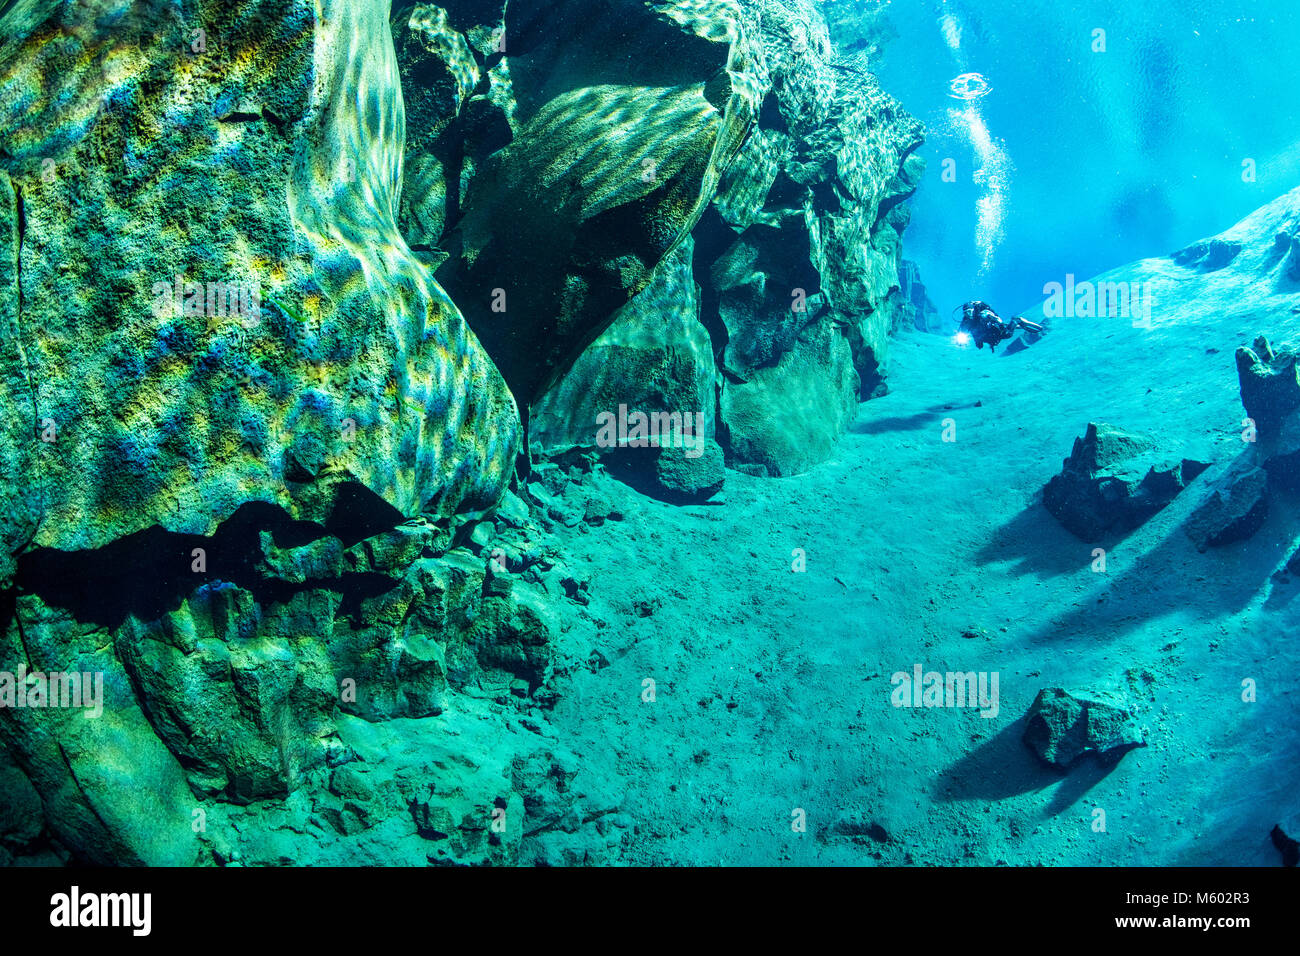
[421,0,758,403]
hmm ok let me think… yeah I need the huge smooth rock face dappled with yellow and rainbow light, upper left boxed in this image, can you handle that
[0,0,520,567]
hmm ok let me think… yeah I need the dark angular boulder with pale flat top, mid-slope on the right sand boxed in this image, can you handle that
[1043,421,1209,541]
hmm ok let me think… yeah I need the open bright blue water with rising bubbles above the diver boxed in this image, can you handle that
[863,0,1300,312]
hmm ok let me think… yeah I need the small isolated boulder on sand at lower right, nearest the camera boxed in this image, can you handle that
[1024,687,1147,769]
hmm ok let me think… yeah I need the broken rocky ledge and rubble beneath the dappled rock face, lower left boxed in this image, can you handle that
[0,463,618,865]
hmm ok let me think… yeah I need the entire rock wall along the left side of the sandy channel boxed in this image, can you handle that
[0,0,920,865]
